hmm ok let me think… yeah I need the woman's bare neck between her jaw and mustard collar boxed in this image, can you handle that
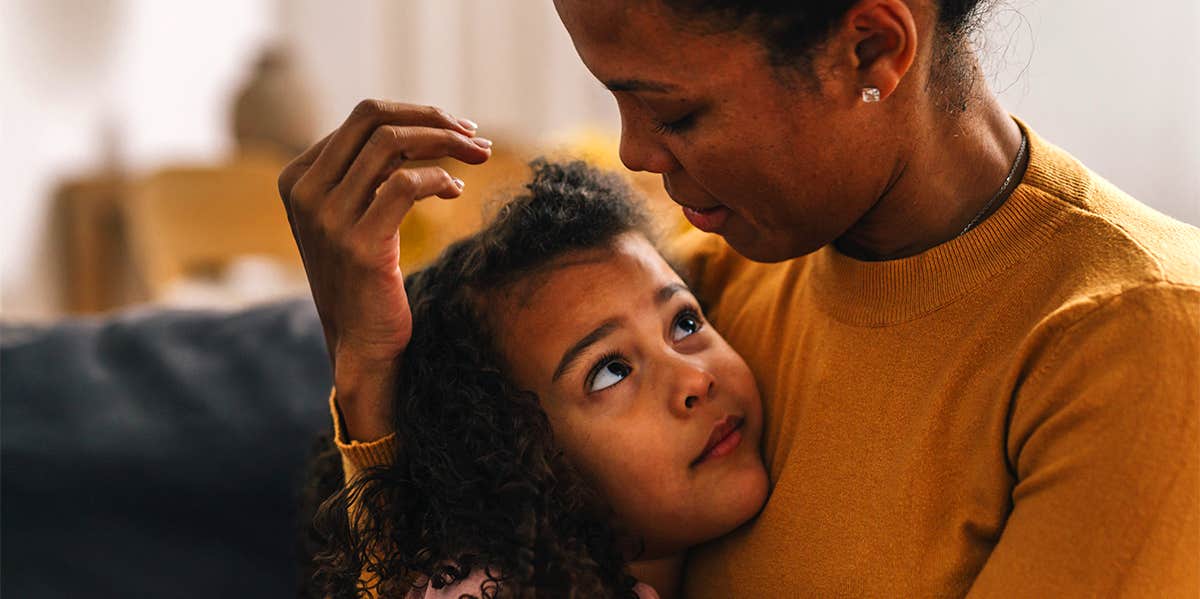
[834,82,1021,260]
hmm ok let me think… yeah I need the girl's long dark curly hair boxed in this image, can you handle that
[306,160,650,598]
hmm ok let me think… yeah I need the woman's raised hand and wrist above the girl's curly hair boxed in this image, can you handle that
[278,100,491,439]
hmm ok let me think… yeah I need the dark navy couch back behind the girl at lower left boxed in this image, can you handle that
[0,299,331,598]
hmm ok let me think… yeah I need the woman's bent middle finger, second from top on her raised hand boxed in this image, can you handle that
[337,125,491,216]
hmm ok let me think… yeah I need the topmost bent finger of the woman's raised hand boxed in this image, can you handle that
[304,100,475,190]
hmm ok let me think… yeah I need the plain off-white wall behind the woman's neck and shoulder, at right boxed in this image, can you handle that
[980,0,1200,226]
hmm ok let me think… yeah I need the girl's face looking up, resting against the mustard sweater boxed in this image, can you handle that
[496,234,767,558]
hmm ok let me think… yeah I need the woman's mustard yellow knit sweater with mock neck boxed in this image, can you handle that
[334,124,1200,599]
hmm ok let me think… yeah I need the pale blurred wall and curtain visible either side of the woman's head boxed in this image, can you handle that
[0,0,1200,324]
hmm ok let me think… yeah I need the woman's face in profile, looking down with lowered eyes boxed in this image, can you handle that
[554,0,899,262]
